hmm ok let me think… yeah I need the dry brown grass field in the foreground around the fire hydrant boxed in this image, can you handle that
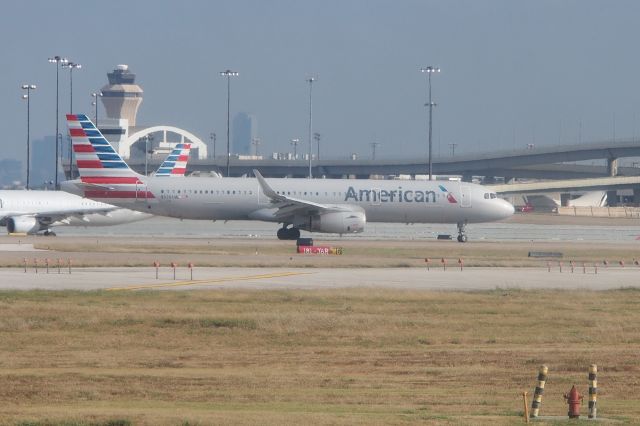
[0,289,640,425]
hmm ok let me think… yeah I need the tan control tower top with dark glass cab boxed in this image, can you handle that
[102,65,142,127]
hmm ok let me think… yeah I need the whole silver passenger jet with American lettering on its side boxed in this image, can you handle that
[63,114,514,242]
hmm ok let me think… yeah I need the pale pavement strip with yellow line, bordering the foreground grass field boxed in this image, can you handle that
[0,265,640,291]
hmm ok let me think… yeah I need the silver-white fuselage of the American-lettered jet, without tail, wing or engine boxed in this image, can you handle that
[65,177,513,223]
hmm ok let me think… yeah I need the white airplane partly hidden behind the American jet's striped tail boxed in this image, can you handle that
[0,143,191,236]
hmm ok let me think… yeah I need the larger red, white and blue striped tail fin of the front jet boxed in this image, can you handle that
[67,114,153,200]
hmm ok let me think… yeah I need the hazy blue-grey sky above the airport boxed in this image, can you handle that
[0,0,640,168]
